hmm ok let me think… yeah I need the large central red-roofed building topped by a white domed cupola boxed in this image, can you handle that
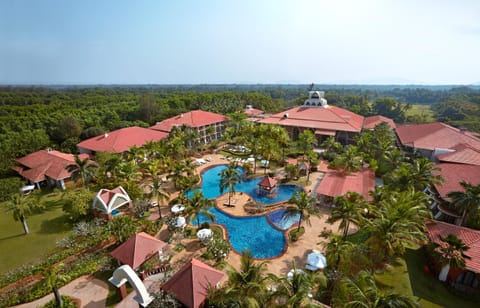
[258,91,395,144]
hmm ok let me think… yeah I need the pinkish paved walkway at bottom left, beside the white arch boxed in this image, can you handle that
[15,276,108,308]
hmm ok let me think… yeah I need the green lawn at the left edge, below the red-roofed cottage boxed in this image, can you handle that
[0,194,72,274]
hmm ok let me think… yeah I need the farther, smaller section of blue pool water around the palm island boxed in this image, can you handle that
[187,165,302,204]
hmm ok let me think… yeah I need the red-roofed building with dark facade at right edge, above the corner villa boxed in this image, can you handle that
[425,163,480,225]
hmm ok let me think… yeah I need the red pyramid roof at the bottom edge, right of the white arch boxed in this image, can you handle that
[162,259,224,308]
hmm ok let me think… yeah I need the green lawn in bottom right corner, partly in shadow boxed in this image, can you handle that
[375,249,480,308]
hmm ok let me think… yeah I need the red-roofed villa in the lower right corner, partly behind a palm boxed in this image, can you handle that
[426,221,480,292]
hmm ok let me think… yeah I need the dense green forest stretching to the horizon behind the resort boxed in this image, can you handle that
[0,84,480,177]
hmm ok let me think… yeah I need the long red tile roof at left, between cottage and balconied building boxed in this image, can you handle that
[77,126,168,153]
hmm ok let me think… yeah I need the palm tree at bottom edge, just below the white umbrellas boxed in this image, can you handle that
[270,264,327,308]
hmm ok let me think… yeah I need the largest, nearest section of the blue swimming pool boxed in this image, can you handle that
[194,207,286,259]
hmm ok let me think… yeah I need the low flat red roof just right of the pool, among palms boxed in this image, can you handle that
[316,169,375,200]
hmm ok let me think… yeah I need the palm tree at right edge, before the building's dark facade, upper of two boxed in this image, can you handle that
[447,181,480,225]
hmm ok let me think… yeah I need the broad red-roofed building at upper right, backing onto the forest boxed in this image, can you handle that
[396,122,480,163]
